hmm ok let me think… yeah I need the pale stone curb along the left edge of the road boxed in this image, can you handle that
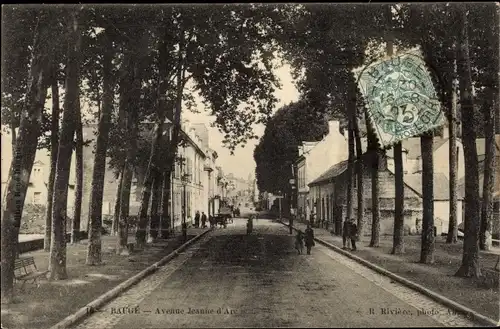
[50,229,211,329]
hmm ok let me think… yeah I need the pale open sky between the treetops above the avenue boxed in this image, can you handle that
[182,64,299,179]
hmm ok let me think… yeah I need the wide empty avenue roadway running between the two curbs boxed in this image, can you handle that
[73,219,471,329]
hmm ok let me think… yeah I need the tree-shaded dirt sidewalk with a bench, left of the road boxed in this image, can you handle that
[2,228,206,329]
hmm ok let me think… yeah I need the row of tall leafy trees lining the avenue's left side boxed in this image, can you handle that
[1,5,284,302]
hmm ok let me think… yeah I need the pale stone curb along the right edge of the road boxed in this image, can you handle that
[278,221,500,327]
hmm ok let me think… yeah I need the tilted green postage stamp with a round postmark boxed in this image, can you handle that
[353,49,444,148]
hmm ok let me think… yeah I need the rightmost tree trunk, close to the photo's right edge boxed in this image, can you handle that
[479,89,496,250]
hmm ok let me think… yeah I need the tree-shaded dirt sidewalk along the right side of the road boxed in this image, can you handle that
[284,219,499,319]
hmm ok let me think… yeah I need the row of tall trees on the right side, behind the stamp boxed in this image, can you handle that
[256,3,499,277]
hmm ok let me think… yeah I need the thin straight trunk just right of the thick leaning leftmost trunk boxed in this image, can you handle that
[43,72,60,251]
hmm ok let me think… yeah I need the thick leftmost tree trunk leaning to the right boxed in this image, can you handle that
[0,19,47,303]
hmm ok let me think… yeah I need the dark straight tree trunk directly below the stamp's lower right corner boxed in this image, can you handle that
[420,133,435,264]
